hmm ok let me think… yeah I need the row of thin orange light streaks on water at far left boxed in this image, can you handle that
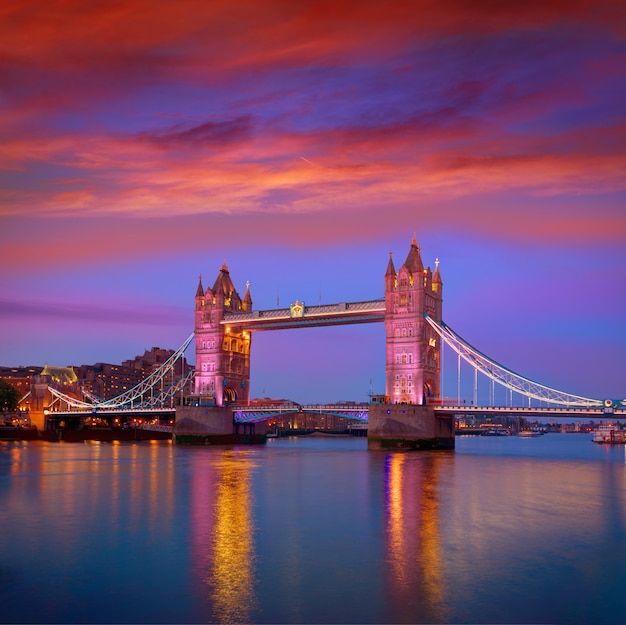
[5,442,174,532]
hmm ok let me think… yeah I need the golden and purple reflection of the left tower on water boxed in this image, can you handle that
[191,449,257,623]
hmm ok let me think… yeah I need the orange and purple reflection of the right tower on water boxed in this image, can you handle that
[385,453,446,622]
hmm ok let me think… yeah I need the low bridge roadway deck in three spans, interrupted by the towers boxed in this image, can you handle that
[48,404,626,423]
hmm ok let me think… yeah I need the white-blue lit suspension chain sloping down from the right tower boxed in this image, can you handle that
[424,314,602,407]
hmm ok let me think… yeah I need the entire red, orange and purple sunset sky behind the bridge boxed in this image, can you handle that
[0,0,626,402]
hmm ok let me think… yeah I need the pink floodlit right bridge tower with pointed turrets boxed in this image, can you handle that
[385,237,443,404]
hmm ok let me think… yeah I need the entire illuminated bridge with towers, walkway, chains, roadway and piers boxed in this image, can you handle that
[35,237,626,448]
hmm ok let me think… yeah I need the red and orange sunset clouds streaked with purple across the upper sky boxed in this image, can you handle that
[0,0,626,258]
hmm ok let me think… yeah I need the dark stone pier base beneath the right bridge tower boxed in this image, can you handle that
[367,404,454,450]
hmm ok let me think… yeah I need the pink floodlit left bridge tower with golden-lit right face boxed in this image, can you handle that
[195,262,252,406]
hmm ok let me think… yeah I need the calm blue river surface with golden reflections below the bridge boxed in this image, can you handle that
[0,434,626,625]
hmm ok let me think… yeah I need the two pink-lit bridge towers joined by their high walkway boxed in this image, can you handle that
[194,237,443,406]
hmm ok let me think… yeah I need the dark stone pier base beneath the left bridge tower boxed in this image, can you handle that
[172,406,267,445]
